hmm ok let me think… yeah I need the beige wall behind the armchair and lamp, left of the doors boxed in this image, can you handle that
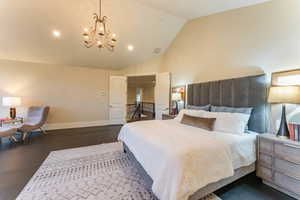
[0,60,117,124]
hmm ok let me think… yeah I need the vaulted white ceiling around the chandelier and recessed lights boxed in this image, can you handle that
[0,0,268,68]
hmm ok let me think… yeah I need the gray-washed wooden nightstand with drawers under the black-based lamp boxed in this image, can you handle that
[256,134,300,199]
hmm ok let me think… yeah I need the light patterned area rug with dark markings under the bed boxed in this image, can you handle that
[17,143,220,200]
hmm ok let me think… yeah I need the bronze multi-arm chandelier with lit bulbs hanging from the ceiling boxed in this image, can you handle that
[83,0,117,51]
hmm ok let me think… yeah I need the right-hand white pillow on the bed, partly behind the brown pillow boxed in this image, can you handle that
[202,112,250,134]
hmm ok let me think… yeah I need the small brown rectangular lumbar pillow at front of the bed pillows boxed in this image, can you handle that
[181,114,216,131]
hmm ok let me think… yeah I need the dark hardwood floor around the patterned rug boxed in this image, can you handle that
[0,126,293,200]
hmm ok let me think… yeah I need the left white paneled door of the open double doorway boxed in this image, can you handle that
[109,76,127,124]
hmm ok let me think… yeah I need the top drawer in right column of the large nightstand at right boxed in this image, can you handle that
[274,143,300,165]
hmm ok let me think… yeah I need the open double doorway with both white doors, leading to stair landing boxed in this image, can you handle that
[109,72,171,124]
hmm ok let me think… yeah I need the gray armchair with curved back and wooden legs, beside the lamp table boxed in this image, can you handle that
[18,106,50,140]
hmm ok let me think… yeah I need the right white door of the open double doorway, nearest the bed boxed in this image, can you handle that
[155,72,171,120]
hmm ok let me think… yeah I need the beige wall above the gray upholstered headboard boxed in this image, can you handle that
[160,0,300,85]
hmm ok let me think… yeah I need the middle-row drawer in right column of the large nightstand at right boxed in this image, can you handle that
[274,158,300,180]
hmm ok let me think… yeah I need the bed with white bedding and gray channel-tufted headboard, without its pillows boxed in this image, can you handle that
[119,75,267,200]
